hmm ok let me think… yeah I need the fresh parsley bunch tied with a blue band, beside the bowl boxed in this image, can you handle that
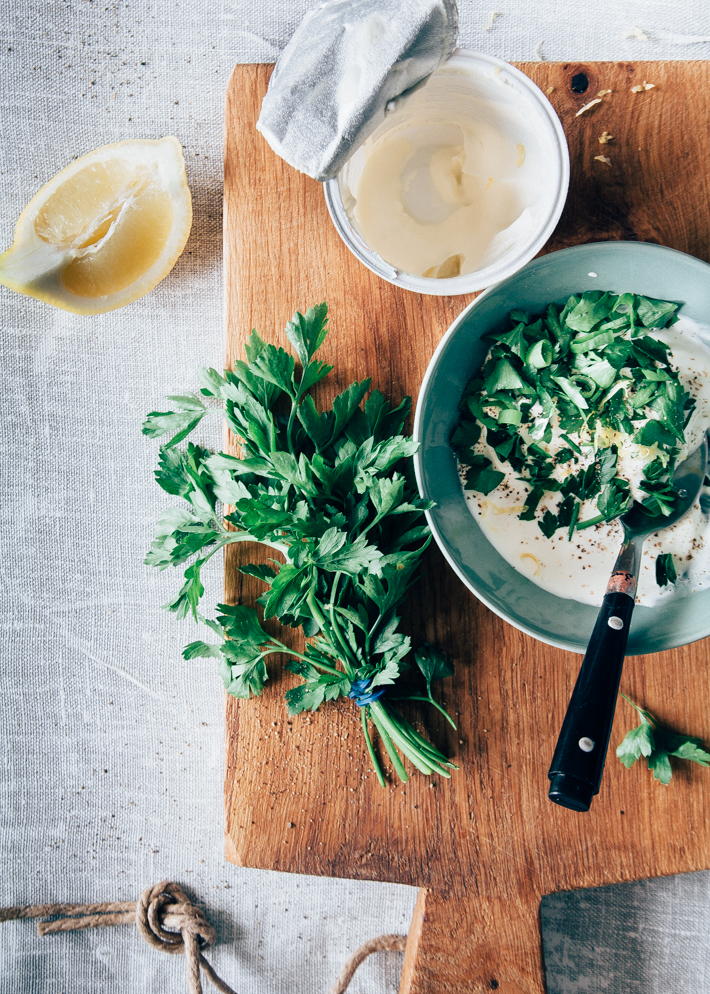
[143,304,456,786]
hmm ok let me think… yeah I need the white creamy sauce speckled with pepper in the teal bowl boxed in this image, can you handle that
[460,317,710,606]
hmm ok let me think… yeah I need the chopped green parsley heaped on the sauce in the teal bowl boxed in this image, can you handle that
[451,290,695,548]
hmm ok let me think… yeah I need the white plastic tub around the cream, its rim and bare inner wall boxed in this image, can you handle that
[323,48,569,297]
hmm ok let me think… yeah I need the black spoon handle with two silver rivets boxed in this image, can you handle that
[548,593,634,811]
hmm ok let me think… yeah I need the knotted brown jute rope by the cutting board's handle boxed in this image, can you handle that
[0,880,407,994]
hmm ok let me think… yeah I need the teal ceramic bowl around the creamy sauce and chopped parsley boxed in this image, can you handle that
[414,242,710,655]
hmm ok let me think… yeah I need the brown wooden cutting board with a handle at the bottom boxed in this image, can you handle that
[224,62,710,994]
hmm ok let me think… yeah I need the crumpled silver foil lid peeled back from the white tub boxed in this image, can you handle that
[257,0,458,180]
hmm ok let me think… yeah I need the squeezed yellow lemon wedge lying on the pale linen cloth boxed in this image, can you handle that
[0,138,192,314]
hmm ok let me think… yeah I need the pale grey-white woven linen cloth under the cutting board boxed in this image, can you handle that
[0,0,710,994]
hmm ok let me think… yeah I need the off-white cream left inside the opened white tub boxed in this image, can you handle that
[340,65,552,278]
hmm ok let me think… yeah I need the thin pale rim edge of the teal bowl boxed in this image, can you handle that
[412,239,710,655]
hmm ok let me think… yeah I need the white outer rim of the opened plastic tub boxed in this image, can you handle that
[323,48,570,297]
